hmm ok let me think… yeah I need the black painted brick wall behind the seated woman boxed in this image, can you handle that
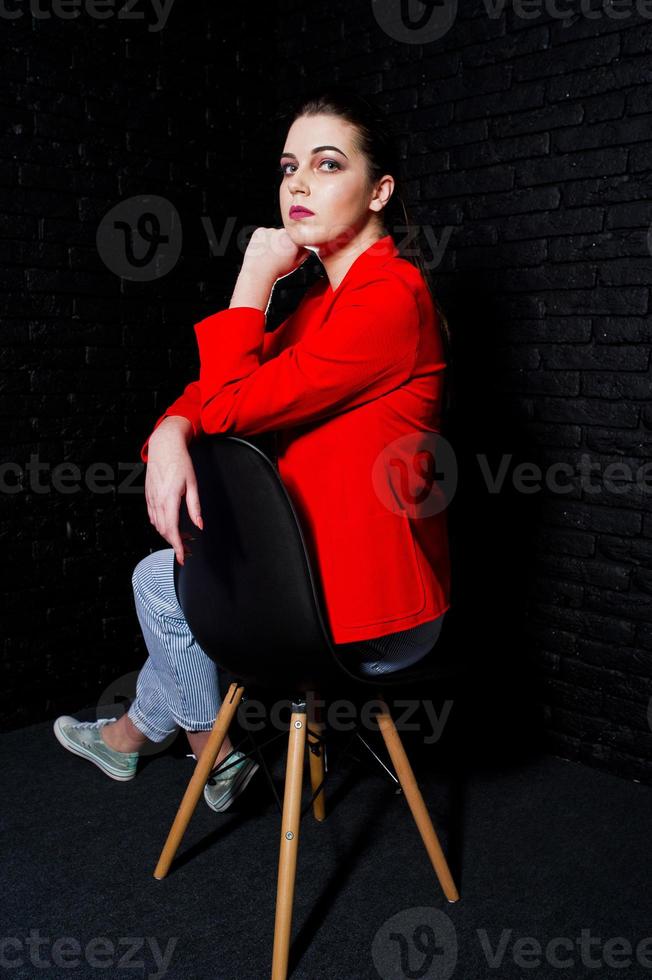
[0,0,652,783]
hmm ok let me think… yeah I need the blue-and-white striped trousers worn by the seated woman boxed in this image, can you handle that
[128,548,446,742]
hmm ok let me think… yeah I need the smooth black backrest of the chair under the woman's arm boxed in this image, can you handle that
[174,435,342,690]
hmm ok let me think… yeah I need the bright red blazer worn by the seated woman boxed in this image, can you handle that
[141,235,450,643]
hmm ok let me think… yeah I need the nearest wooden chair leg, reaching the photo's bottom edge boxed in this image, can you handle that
[272,701,306,980]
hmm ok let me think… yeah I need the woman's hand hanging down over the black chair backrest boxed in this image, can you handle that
[145,415,203,565]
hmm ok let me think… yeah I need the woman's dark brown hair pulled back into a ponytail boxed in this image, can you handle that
[287,85,452,384]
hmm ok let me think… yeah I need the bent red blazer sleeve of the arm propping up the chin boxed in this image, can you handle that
[195,274,420,435]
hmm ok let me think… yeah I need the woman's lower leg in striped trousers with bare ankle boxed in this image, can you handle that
[102,548,232,762]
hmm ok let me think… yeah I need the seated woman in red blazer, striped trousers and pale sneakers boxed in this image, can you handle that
[55,88,450,811]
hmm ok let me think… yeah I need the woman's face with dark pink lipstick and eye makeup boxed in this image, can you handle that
[279,115,393,252]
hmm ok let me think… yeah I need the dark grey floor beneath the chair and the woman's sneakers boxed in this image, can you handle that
[5,696,652,980]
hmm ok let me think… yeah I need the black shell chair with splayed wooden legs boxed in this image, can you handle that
[154,435,459,980]
